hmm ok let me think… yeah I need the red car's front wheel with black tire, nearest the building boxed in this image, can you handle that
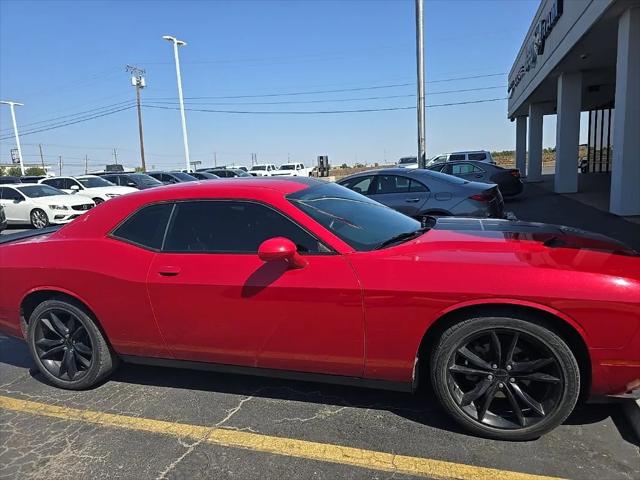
[430,316,580,441]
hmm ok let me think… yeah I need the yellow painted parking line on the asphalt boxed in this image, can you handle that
[0,395,557,480]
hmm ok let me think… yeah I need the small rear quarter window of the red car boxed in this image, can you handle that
[112,203,173,250]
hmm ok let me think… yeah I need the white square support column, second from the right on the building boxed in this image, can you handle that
[554,72,582,193]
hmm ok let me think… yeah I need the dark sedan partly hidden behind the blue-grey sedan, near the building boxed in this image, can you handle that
[427,160,524,197]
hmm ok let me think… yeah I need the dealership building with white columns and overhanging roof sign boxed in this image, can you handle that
[508,0,640,215]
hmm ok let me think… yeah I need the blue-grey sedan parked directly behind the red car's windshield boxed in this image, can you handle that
[337,168,504,218]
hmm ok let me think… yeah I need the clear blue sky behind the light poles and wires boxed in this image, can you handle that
[0,0,555,173]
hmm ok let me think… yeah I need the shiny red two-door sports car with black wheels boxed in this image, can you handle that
[0,178,640,439]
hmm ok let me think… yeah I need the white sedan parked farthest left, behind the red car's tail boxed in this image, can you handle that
[0,183,95,228]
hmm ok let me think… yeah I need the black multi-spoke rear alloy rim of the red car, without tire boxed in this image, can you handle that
[35,309,93,381]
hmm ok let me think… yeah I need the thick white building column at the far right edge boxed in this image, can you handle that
[609,8,640,215]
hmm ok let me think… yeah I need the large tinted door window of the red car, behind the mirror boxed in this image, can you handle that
[163,200,326,253]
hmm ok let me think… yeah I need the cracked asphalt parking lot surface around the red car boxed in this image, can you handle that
[0,187,640,479]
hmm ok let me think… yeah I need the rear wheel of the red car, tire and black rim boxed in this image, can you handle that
[27,299,117,390]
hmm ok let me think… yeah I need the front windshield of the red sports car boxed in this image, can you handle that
[287,183,421,251]
